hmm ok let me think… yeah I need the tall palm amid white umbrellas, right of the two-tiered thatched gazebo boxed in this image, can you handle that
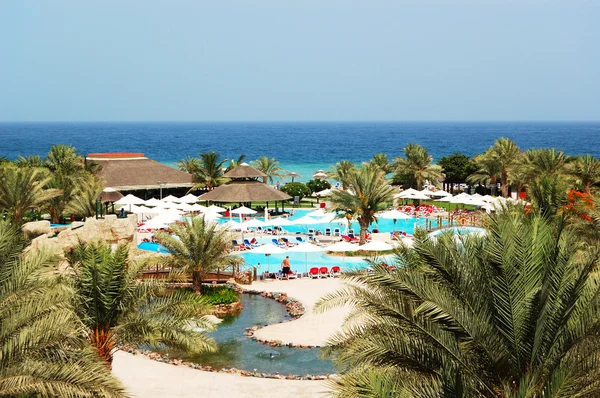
[330,167,394,245]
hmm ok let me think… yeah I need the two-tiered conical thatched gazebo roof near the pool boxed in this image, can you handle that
[198,164,291,203]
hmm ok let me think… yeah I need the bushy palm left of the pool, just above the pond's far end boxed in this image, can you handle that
[155,216,241,293]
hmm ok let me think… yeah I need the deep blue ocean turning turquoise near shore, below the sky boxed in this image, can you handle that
[0,122,600,181]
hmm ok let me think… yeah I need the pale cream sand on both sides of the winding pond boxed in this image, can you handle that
[113,278,348,398]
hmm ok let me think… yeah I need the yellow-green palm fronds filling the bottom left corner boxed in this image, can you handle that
[0,221,125,397]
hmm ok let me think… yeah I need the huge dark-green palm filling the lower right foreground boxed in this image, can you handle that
[317,208,600,398]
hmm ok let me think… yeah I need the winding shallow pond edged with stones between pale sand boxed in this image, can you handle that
[157,294,335,376]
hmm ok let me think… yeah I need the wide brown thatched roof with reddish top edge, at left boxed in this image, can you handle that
[86,153,193,191]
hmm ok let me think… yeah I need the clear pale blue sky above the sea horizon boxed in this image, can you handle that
[0,0,600,121]
